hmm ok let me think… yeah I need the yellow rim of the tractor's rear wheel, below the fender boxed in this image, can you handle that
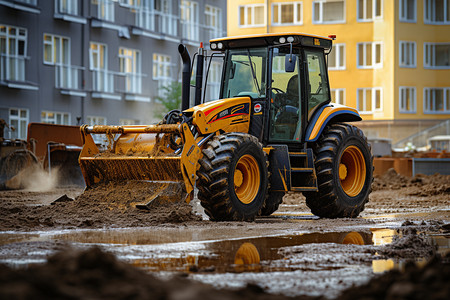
[339,146,366,197]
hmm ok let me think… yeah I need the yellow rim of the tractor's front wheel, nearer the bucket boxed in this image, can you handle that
[234,154,261,204]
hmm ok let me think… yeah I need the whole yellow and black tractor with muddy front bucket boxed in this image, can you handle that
[79,33,373,221]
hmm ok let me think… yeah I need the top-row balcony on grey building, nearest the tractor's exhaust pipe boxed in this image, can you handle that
[133,9,180,42]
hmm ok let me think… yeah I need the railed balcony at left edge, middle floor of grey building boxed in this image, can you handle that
[0,54,39,90]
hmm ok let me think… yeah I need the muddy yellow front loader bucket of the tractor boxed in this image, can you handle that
[79,125,192,208]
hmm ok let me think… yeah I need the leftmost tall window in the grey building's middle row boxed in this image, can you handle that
[0,25,27,81]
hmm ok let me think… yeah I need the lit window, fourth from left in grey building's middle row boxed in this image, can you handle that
[119,48,142,94]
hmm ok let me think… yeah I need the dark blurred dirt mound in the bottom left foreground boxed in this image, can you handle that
[0,248,314,300]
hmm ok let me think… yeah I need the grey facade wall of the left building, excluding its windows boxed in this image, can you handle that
[0,0,226,138]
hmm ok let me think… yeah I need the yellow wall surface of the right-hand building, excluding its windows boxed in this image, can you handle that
[227,0,450,142]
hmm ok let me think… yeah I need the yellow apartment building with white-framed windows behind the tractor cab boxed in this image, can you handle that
[227,0,450,143]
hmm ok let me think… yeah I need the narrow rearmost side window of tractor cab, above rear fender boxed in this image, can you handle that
[305,50,330,119]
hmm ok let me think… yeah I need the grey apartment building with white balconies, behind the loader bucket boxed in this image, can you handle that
[0,0,226,139]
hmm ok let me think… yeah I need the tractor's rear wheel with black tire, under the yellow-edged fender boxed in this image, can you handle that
[304,123,373,218]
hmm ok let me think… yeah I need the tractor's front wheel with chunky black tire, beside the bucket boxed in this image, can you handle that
[197,133,268,221]
